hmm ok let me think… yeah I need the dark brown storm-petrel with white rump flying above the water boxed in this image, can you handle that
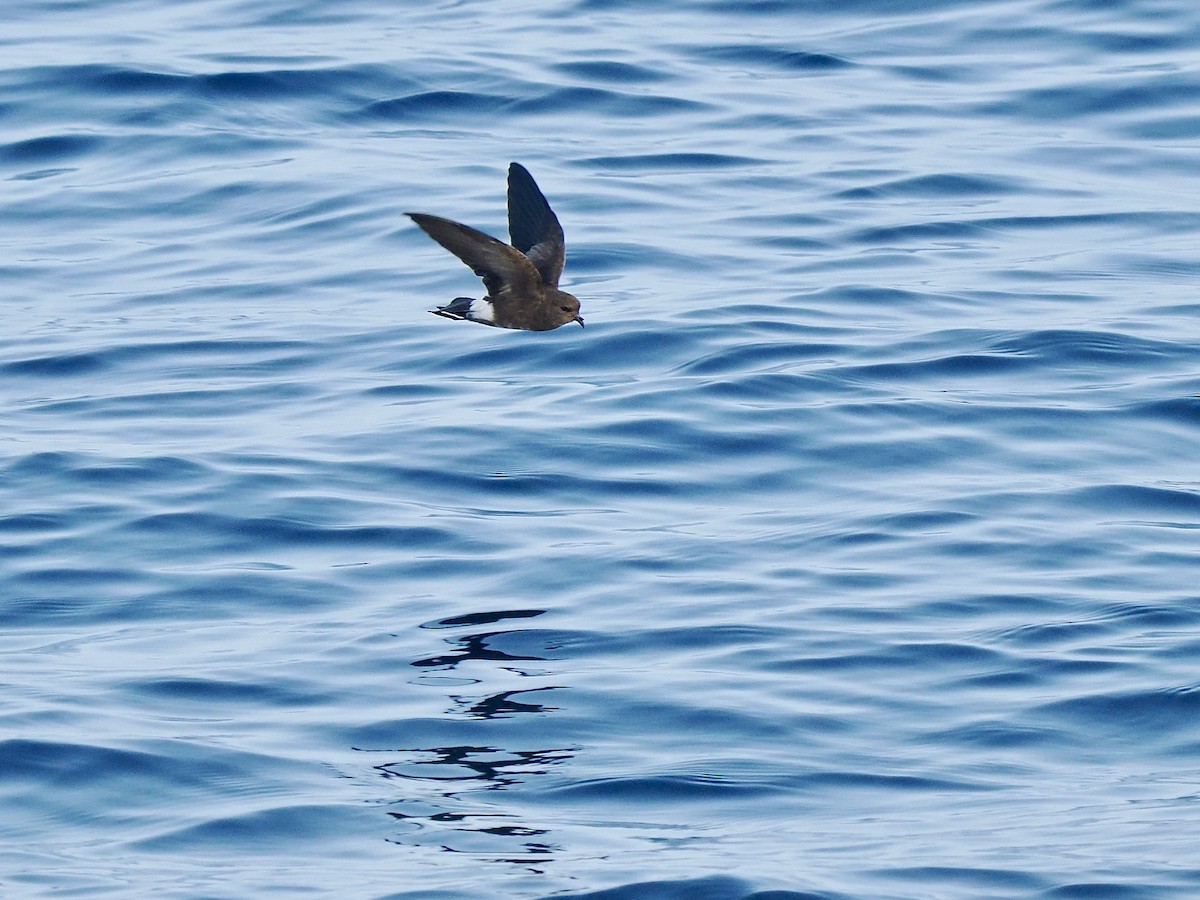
[404,162,583,331]
